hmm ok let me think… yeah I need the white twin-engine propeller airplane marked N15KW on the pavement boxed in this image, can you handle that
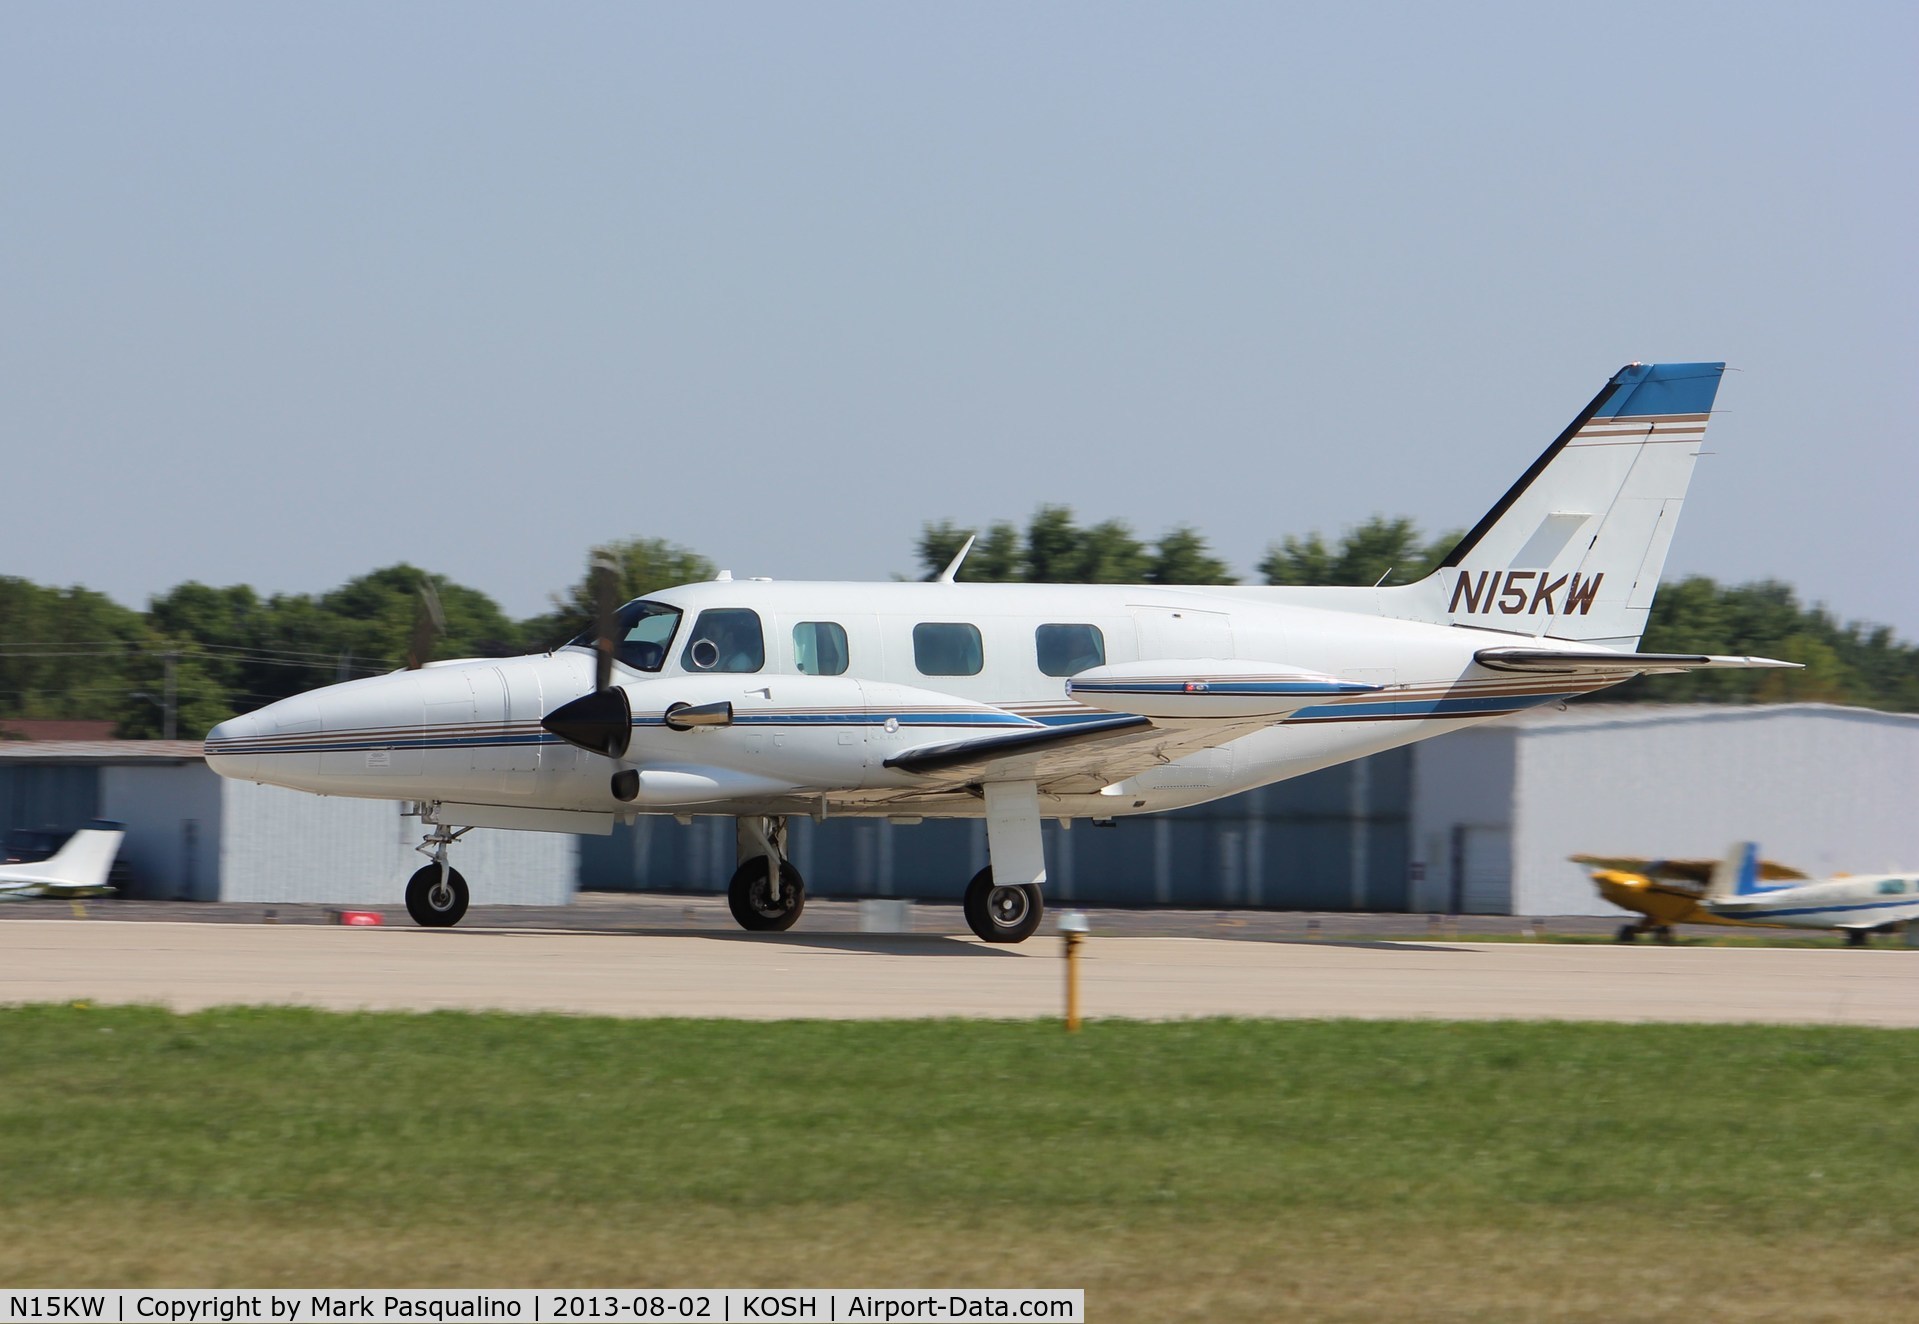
[207,363,1790,942]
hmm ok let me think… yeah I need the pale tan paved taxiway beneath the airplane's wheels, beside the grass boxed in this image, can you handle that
[0,919,1919,1027]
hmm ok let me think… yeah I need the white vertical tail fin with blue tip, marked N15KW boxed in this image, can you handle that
[1407,363,1725,650]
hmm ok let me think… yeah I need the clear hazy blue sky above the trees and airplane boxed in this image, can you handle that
[0,4,1919,639]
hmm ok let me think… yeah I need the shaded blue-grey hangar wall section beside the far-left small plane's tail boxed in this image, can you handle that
[100,762,225,902]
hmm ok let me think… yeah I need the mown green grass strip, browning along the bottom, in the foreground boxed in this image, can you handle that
[0,1007,1919,1320]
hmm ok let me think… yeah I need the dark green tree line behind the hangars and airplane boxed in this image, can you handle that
[0,505,1919,739]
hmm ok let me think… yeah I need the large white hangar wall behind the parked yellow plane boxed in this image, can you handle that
[1514,704,1919,915]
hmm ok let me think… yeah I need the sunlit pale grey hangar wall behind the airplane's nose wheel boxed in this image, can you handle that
[221,781,580,906]
